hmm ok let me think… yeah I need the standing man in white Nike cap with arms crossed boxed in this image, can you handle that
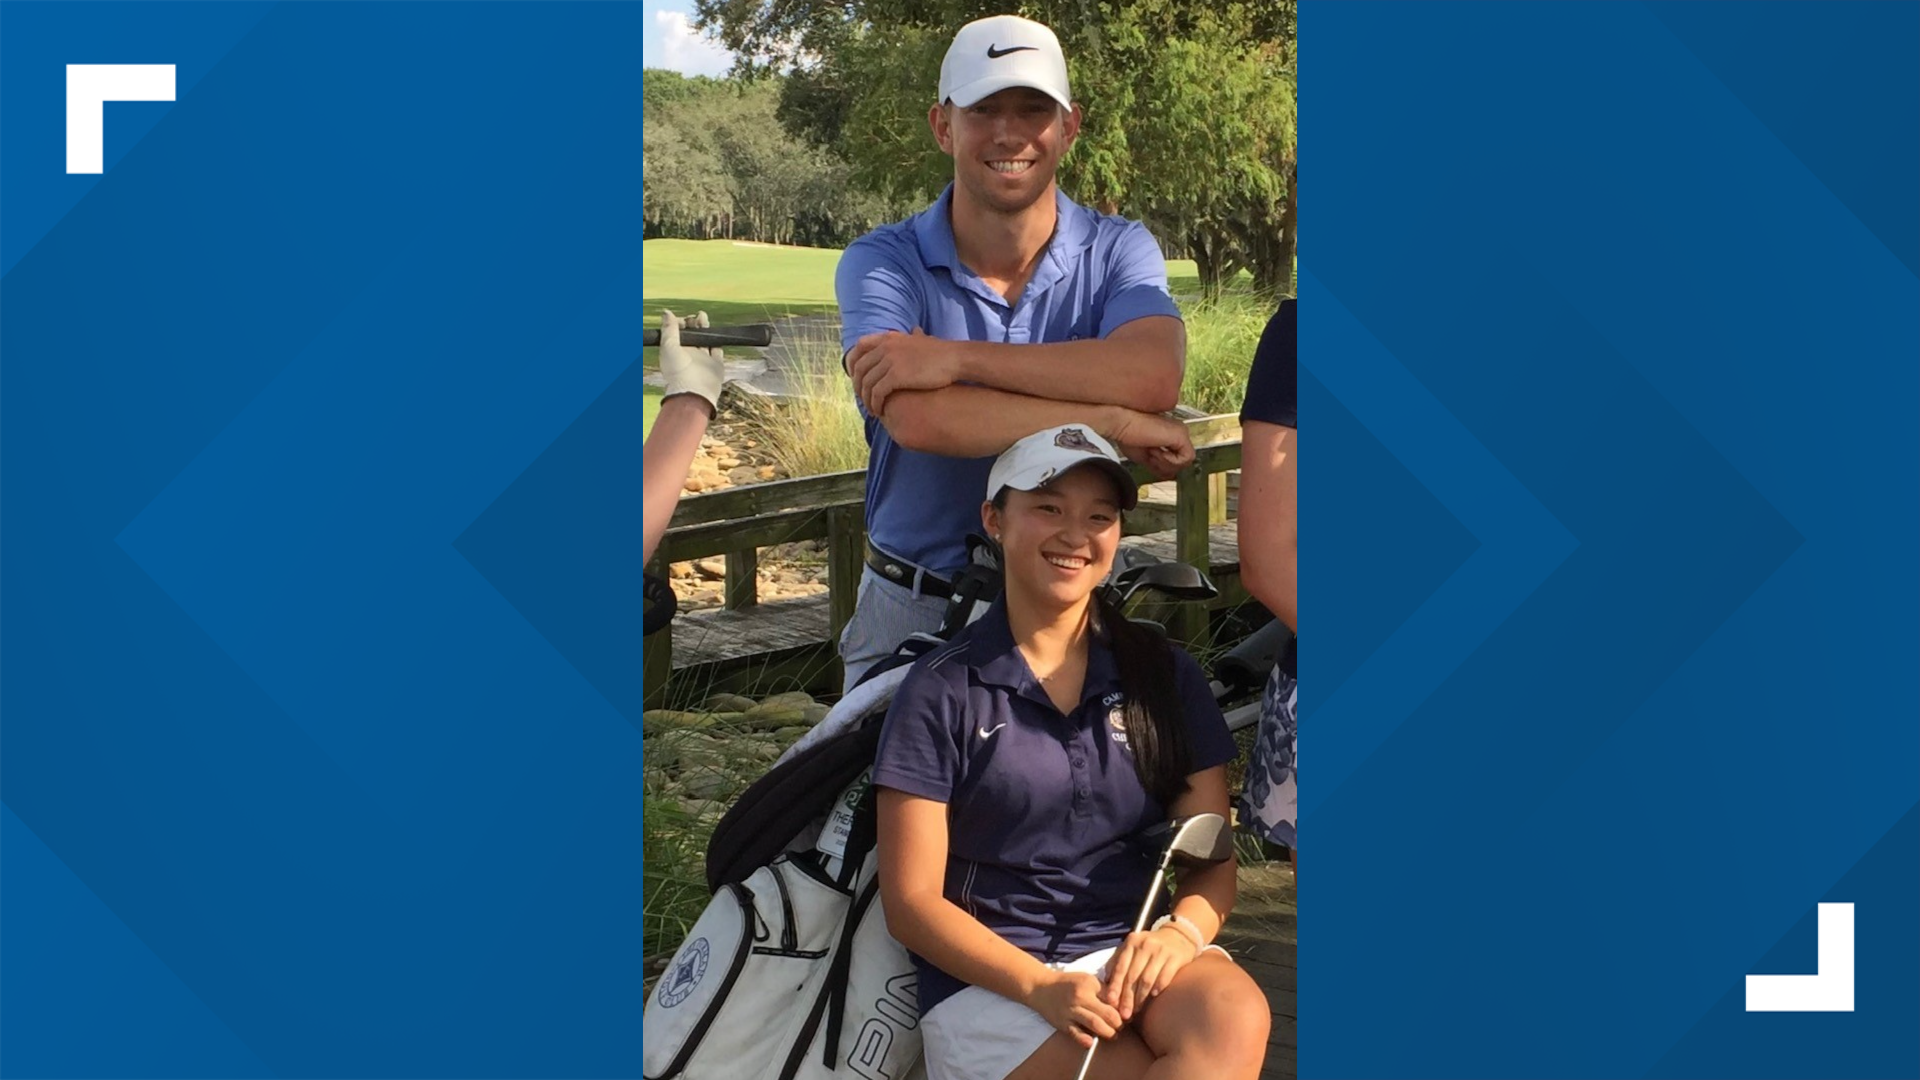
[835,15,1192,688]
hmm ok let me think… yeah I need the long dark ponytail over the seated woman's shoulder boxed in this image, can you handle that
[993,488,1194,807]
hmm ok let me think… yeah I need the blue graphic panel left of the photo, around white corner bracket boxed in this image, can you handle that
[0,0,641,1078]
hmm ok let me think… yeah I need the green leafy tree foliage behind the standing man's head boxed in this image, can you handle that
[697,0,1296,290]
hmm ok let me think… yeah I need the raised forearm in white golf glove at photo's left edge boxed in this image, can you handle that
[639,309,726,563]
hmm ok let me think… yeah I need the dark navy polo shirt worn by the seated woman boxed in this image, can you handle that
[874,603,1236,1013]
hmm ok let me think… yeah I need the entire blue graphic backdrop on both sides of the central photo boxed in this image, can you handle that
[0,0,1920,1078]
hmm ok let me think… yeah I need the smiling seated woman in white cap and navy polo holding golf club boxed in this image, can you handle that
[874,425,1269,1080]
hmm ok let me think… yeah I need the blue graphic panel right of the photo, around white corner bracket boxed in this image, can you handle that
[1300,2,1920,1078]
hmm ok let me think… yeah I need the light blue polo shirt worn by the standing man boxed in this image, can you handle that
[833,184,1181,575]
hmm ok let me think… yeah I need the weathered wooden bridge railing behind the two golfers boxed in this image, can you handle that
[647,415,1240,687]
